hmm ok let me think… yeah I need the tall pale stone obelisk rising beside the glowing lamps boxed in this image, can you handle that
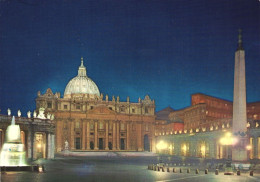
[232,30,248,162]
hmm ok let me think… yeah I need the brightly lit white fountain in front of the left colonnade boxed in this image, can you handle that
[0,116,43,171]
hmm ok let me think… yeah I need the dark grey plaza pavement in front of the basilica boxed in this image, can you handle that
[1,152,260,182]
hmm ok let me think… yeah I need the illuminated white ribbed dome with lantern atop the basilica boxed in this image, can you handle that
[64,58,100,98]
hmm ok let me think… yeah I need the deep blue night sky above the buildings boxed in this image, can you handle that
[0,0,260,116]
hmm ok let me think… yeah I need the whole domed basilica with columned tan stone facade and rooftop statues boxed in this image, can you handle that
[36,58,155,152]
